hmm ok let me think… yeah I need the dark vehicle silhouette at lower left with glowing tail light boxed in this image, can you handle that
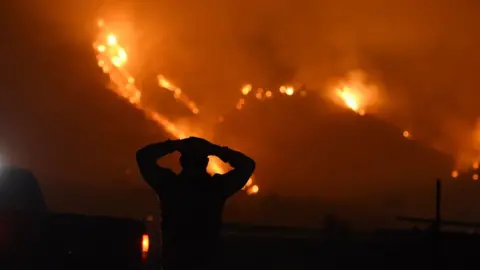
[0,166,148,270]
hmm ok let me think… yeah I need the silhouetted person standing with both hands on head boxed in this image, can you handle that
[137,137,255,270]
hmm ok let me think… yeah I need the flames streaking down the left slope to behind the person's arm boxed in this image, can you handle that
[93,20,259,194]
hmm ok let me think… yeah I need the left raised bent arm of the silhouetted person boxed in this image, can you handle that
[137,140,178,190]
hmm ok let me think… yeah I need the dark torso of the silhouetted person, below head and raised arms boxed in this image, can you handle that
[157,175,225,261]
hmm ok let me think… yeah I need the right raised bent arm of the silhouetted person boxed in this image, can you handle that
[209,144,255,197]
